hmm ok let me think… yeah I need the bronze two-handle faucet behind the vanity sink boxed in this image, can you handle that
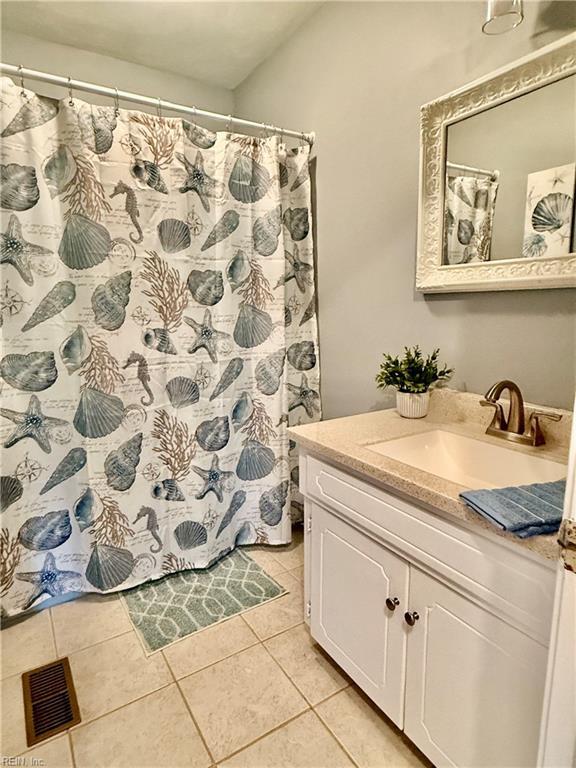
[480,379,562,446]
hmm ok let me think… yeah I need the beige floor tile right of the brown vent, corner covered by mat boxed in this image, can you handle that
[70,632,172,721]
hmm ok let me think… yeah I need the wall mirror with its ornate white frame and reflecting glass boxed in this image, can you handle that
[417,35,576,292]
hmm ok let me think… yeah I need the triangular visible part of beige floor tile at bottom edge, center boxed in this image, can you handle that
[220,712,354,768]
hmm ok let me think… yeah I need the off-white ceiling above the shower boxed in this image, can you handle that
[1,0,321,88]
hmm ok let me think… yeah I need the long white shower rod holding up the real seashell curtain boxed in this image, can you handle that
[0,63,315,146]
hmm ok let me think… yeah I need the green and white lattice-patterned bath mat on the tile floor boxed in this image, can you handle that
[122,550,288,653]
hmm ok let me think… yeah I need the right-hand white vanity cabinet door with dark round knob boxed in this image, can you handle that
[404,568,546,768]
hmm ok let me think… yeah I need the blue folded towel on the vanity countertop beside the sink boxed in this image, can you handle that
[460,480,566,539]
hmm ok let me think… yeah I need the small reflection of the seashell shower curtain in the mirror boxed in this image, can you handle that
[444,176,498,264]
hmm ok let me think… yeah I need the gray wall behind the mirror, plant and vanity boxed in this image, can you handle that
[236,2,576,418]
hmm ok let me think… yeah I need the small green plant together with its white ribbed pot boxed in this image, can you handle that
[376,346,454,419]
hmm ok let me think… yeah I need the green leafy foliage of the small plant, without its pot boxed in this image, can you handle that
[376,346,454,394]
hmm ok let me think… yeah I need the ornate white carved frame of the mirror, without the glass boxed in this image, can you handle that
[416,33,576,293]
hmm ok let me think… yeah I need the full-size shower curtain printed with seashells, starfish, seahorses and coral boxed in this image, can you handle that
[0,79,320,615]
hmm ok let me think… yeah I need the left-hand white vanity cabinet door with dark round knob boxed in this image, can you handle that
[310,504,409,727]
